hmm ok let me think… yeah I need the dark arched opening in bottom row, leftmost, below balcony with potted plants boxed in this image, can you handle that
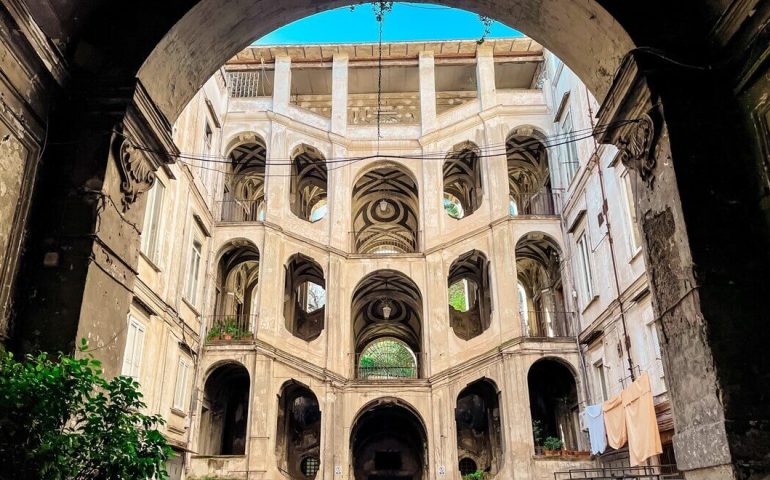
[198,363,249,455]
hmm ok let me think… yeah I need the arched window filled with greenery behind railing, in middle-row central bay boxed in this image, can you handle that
[357,338,417,379]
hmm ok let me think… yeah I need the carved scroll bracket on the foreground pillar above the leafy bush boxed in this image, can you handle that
[111,125,155,213]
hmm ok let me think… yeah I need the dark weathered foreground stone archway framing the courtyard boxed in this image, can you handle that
[9,0,770,476]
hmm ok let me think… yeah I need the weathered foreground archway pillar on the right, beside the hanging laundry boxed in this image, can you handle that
[597,51,770,480]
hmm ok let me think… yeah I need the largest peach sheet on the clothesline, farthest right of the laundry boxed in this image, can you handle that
[621,372,663,467]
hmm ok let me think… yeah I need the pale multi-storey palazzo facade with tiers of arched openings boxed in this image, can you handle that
[122,38,673,479]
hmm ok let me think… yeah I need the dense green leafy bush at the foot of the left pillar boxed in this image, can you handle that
[0,340,172,480]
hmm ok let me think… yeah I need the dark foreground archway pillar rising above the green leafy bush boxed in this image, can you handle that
[15,85,178,376]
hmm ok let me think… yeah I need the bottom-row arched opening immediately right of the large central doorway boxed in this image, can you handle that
[455,378,503,476]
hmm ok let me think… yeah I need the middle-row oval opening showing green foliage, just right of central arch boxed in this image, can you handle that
[447,250,492,340]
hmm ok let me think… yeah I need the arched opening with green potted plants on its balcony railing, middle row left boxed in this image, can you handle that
[207,240,259,340]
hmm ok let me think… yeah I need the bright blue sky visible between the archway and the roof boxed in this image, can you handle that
[255,3,521,45]
